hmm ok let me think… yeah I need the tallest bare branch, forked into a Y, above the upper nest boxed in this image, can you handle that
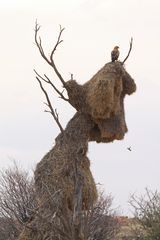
[35,21,66,87]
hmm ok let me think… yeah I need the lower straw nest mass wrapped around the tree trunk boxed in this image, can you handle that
[35,114,97,209]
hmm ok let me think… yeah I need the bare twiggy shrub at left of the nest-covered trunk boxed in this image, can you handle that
[0,164,37,240]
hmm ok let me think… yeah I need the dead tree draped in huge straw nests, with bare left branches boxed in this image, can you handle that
[20,23,136,240]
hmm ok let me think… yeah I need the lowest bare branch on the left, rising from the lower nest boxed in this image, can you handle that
[36,76,63,132]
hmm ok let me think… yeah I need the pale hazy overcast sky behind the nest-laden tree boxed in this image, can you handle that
[0,0,160,214]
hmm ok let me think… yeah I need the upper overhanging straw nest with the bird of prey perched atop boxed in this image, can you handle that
[67,62,136,142]
